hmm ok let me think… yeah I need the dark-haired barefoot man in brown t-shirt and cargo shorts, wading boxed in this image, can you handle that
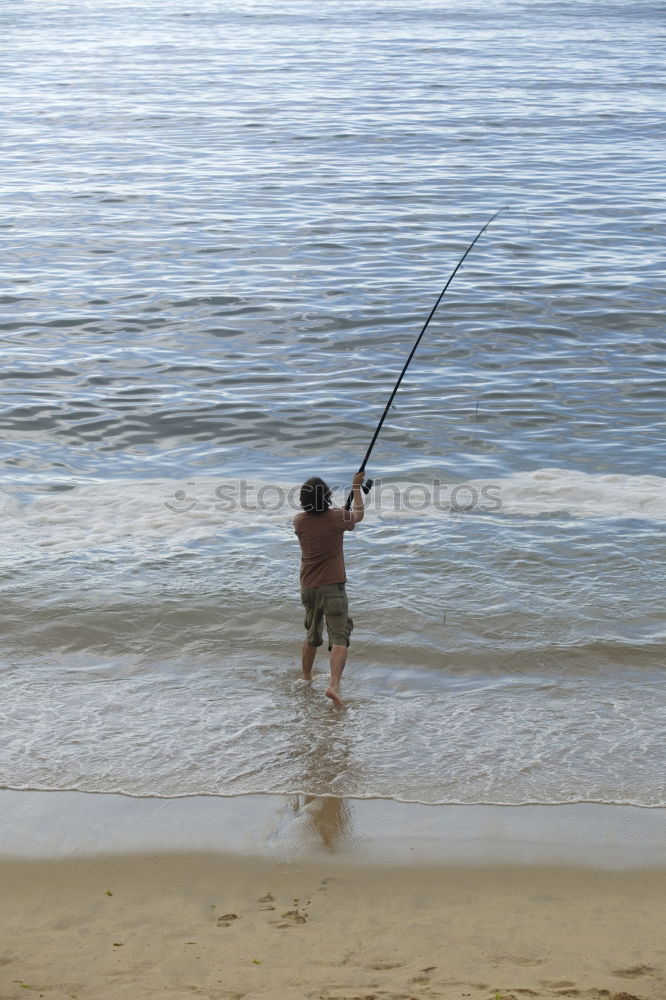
[294,472,364,708]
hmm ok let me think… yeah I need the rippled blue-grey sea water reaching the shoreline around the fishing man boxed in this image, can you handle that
[0,0,666,807]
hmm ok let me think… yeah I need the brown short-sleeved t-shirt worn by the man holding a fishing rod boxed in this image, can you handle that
[294,507,355,590]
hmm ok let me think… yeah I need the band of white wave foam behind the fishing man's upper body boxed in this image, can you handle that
[0,469,666,553]
